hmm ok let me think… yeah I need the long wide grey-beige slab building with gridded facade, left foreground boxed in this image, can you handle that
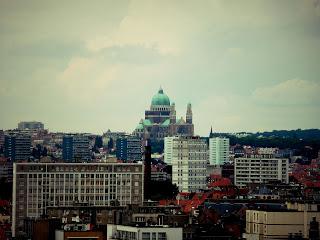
[12,163,144,236]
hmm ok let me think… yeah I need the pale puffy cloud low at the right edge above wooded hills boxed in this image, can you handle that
[253,79,320,105]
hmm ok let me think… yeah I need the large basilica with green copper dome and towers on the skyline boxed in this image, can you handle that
[133,88,194,140]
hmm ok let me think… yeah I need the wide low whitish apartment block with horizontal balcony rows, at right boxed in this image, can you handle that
[234,155,289,187]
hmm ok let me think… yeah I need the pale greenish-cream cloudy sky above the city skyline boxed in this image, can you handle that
[0,0,320,135]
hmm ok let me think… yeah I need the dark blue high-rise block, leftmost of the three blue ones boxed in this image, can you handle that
[4,134,31,161]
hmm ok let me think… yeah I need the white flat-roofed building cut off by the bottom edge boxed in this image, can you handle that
[107,224,182,240]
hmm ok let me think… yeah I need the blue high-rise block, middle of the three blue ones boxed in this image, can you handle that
[62,134,91,162]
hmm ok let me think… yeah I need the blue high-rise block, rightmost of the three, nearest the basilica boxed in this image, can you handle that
[116,136,142,161]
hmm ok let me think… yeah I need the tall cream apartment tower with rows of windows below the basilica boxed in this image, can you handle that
[172,137,208,192]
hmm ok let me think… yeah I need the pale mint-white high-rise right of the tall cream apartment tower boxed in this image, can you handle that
[209,137,230,165]
